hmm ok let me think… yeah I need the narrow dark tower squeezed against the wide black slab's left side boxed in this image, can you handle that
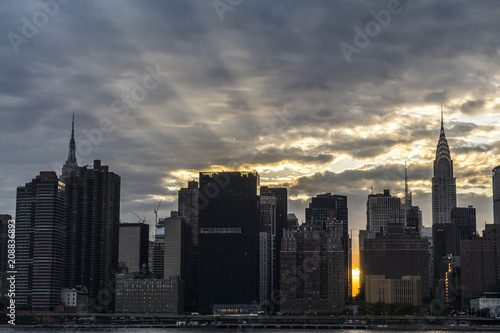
[178,180,200,313]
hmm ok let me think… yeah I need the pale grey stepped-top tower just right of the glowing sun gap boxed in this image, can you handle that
[366,190,404,238]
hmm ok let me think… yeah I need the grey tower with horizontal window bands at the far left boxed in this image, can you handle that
[16,171,67,311]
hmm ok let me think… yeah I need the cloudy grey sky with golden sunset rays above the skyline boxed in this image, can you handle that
[0,0,500,264]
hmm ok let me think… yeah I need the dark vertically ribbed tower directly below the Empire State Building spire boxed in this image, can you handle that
[65,160,121,312]
